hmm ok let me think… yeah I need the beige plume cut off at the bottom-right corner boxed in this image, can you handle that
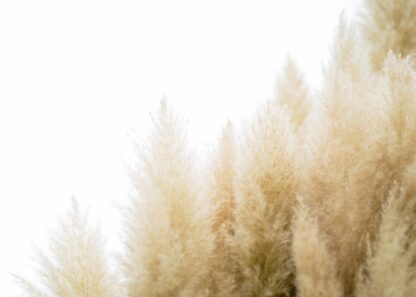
[357,185,416,297]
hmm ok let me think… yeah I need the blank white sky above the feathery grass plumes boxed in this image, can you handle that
[0,0,361,297]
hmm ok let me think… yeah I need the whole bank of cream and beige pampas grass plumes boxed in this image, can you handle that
[18,0,416,297]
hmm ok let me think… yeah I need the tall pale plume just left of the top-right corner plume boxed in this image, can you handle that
[300,21,390,296]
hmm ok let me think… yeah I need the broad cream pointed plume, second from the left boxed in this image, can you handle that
[119,101,213,297]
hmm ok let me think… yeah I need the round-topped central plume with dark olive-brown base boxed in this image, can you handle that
[233,102,297,297]
